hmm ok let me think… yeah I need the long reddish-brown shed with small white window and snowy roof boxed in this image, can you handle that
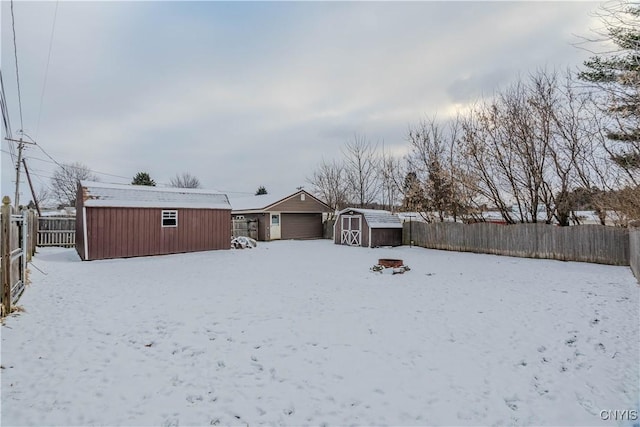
[76,181,231,261]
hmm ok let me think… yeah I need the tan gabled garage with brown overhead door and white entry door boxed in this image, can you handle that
[231,190,332,241]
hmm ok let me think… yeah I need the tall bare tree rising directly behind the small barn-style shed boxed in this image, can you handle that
[342,135,380,208]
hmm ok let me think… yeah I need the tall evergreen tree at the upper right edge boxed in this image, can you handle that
[579,0,640,184]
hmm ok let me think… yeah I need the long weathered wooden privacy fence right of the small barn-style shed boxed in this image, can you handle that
[403,222,629,265]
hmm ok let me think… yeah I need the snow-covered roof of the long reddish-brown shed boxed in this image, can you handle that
[80,181,231,209]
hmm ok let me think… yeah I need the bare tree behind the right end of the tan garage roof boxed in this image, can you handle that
[307,159,347,210]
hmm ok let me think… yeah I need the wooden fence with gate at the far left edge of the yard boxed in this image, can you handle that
[0,197,36,316]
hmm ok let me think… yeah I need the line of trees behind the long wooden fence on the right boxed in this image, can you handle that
[307,2,640,225]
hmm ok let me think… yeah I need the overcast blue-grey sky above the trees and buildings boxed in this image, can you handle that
[1,1,599,203]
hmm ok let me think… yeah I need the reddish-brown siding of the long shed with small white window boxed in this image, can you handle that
[77,207,231,260]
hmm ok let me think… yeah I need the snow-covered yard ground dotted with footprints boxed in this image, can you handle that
[1,240,640,426]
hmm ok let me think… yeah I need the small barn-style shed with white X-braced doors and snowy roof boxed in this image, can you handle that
[333,208,402,248]
